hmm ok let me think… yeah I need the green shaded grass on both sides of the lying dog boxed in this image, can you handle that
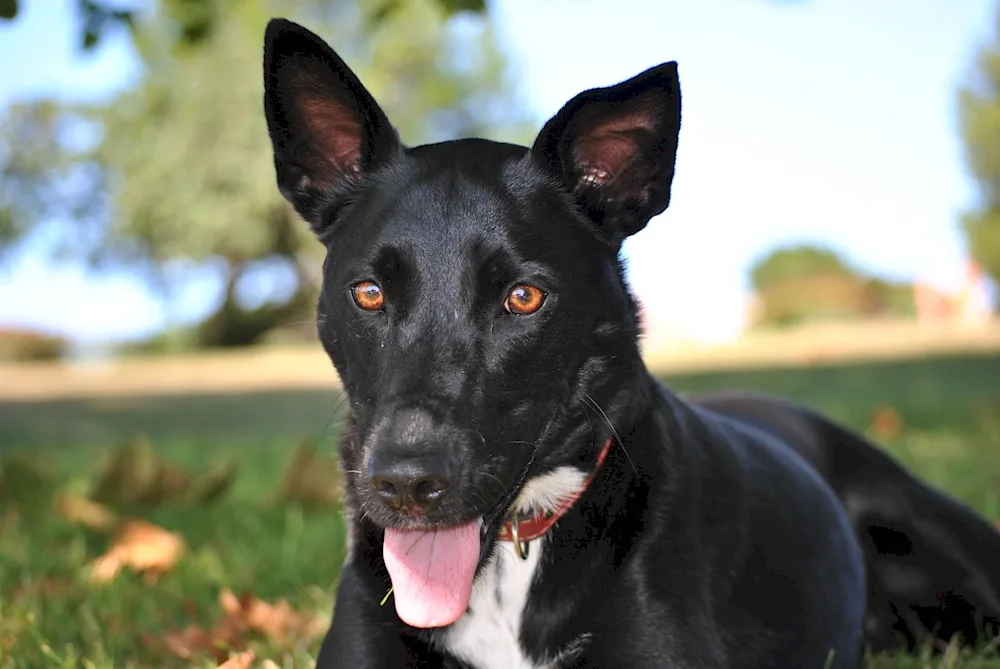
[0,355,1000,669]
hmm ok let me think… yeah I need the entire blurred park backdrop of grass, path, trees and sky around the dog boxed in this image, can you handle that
[0,0,1000,667]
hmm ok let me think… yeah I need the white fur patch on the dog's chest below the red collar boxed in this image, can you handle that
[437,541,549,669]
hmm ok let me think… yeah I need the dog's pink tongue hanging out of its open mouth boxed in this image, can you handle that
[382,520,482,628]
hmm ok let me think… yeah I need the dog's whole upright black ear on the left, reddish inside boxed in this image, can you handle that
[264,19,402,234]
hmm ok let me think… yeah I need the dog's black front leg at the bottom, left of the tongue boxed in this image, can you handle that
[316,560,442,669]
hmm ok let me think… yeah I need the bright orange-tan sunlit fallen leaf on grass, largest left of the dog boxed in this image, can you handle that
[90,520,186,583]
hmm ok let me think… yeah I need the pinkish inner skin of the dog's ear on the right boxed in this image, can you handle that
[573,108,655,186]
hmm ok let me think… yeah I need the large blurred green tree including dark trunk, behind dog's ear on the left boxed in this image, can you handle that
[0,0,523,345]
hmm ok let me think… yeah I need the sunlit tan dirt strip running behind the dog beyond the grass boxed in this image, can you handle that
[0,321,1000,402]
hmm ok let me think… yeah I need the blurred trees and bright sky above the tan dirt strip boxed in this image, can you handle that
[0,0,1000,359]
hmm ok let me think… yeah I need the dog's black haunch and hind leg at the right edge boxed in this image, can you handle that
[692,392,1000,651]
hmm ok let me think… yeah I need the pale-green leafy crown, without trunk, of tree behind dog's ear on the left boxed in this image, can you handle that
[99,0,528,266]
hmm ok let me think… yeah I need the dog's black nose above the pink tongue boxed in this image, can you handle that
[368,451,451,515]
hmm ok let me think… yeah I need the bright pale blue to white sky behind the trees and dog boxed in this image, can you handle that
[0,0,995,341]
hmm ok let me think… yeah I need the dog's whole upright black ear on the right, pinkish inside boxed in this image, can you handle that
[531,62,681,244]
